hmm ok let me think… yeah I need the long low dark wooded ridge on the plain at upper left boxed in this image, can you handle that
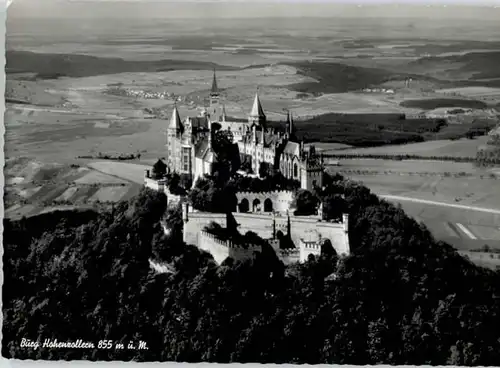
[5,50,236,79]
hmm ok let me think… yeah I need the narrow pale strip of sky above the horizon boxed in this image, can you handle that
[8,0,500,22]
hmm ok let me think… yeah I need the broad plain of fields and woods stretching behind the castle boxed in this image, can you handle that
[5,13,500,262]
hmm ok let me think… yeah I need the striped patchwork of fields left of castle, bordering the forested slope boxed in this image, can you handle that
[5,158,143,218]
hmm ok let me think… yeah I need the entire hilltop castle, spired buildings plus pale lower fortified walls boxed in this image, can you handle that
[149,71,350,264]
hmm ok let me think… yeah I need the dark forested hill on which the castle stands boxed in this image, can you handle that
[2,181,500,365]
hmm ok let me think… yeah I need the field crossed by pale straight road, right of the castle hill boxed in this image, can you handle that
[331,160,500,250]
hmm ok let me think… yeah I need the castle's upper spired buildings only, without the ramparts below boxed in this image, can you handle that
[166,71,324,190]
